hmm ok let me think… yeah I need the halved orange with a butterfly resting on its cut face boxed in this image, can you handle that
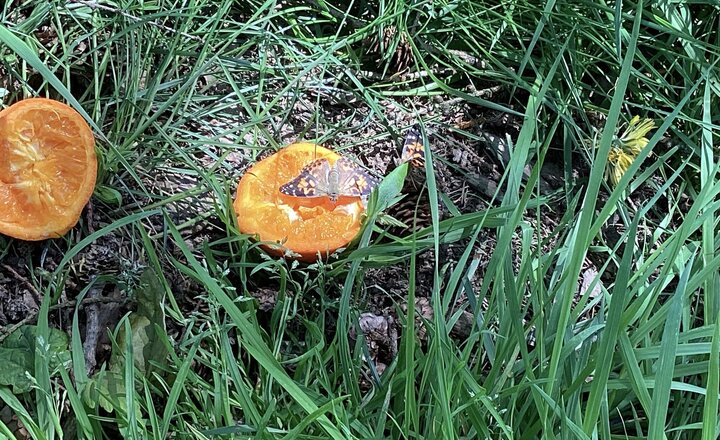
[234,142,365,262]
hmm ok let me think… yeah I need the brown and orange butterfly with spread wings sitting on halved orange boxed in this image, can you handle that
[280,157,378,202]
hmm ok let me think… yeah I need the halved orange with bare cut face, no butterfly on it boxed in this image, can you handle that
[0,98,97,240]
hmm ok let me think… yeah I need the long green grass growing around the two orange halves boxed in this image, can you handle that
[0,0,720,440]
